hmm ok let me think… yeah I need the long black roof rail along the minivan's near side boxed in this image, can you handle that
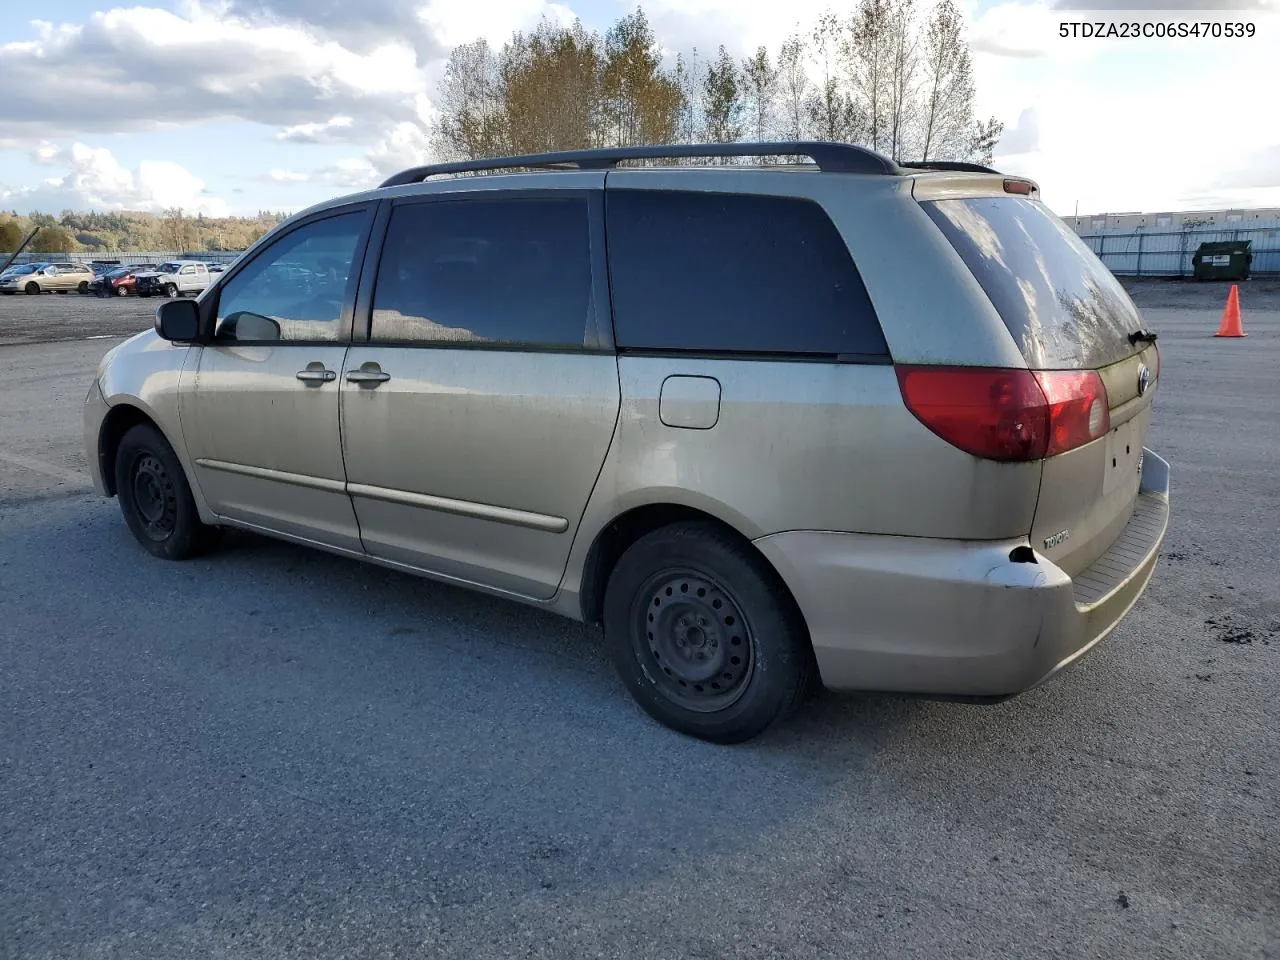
[379,141,901,187]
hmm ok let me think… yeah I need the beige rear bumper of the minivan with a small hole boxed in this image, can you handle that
[755,451,1170,698]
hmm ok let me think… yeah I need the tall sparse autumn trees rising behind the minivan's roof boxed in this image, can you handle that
[431,0,1004,163]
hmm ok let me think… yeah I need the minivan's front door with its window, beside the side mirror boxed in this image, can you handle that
[182,205,372,552]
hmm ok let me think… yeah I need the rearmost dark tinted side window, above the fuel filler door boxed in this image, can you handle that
[607,189,887,357]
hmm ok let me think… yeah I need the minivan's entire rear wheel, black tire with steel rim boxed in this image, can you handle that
[604,521,813,744]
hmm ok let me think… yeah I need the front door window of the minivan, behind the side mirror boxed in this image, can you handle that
[214,211,367,343]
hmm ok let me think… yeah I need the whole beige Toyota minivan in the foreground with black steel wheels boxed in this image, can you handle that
[84,143,1170,742]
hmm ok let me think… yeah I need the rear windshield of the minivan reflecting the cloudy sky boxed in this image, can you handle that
[923,197,1142,369]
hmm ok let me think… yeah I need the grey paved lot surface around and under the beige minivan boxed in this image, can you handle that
[0,282,1280,960]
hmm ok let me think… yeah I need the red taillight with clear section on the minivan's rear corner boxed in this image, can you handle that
[897,366,1111,461]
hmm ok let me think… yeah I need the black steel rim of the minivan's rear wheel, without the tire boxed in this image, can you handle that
[632,570,755,713]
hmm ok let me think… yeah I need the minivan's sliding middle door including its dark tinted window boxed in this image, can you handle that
[342,184,620,599]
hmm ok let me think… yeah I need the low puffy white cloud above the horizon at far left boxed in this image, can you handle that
[0,142,229,216]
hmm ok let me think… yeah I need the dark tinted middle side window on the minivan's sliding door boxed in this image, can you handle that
[372,197,591,347]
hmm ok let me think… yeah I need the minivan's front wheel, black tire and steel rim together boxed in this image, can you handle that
[115,424,221,561]
